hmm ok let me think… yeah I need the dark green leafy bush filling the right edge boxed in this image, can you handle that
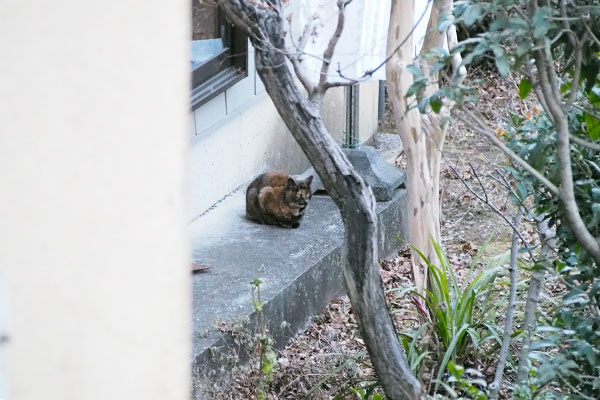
[416,0,600,399]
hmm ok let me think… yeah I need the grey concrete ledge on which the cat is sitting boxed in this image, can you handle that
[191,189,406,399]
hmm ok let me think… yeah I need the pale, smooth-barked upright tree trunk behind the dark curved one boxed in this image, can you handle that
[386,0,460,291]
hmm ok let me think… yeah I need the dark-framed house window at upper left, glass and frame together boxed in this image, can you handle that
[190,0,248,110]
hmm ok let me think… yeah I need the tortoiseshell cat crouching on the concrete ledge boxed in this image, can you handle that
[246,172,313,228]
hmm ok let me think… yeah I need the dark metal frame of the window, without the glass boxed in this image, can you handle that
[190,9,248,111]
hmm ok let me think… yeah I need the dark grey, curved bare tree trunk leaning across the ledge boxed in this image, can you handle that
[220,0,422,400]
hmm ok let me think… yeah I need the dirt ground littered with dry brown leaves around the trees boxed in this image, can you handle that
[199,67,548,399]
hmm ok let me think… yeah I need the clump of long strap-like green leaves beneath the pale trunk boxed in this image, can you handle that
[394,241,502,391]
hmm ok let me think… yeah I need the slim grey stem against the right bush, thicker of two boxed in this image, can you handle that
[516,220,556,384]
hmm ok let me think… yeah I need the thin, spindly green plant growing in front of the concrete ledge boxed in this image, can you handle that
[250,278,277,400]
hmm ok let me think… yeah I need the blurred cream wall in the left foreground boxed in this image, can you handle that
[0,0,191,400]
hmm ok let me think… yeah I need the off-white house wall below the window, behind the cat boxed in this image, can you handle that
[190,42,378,219]
